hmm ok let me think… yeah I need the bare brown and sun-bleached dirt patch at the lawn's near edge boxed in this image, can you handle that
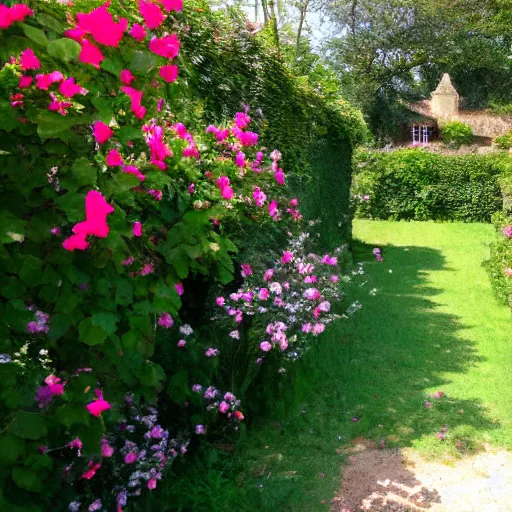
[331,441,512,512]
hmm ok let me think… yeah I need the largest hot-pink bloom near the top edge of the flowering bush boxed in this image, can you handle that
[76,2,128,47]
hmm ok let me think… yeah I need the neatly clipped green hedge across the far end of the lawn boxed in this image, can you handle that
[352,149,507,222]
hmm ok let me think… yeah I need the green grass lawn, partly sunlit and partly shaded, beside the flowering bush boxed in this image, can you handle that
[157,220,512,512]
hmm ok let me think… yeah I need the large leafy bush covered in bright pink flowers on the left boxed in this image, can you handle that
[0,0,364,512]
